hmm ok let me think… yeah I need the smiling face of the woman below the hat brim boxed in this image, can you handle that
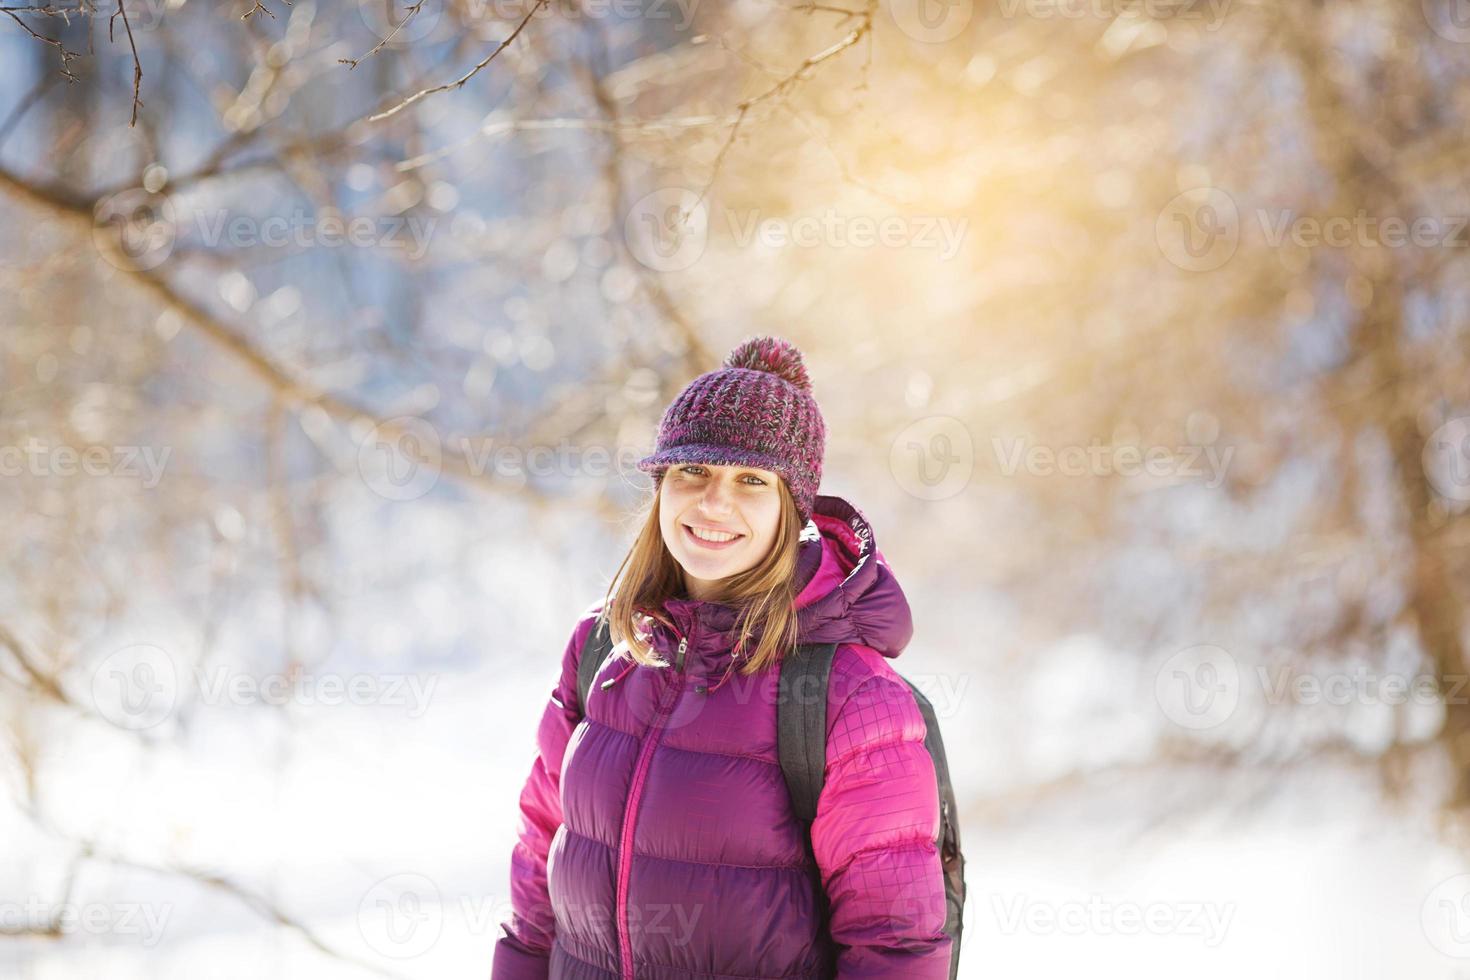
[659,463,781,599]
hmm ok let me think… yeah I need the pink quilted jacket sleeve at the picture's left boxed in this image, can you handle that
[490,617,592,980]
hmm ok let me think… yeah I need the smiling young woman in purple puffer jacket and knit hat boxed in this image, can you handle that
[492,338,950,980]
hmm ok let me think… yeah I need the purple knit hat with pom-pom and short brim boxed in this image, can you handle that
[638,336,826,525]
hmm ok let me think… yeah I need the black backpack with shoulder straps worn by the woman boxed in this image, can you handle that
[576,619,964,980]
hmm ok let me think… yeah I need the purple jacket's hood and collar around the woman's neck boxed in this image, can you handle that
[637,494,913,674]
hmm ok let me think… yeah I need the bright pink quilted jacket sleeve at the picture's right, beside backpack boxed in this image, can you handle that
[811,671,951,980]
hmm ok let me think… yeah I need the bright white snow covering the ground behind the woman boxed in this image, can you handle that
[0,646,1470,980]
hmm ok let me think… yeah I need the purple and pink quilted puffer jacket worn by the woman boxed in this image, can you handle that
[491,495,950,980]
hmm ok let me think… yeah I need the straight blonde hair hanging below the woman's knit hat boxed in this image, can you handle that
[601,479,801,676]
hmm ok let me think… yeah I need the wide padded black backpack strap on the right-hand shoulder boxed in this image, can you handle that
[776,644,836,826]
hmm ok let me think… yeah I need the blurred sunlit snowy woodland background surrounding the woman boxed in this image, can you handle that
[0,0,1470,980]
